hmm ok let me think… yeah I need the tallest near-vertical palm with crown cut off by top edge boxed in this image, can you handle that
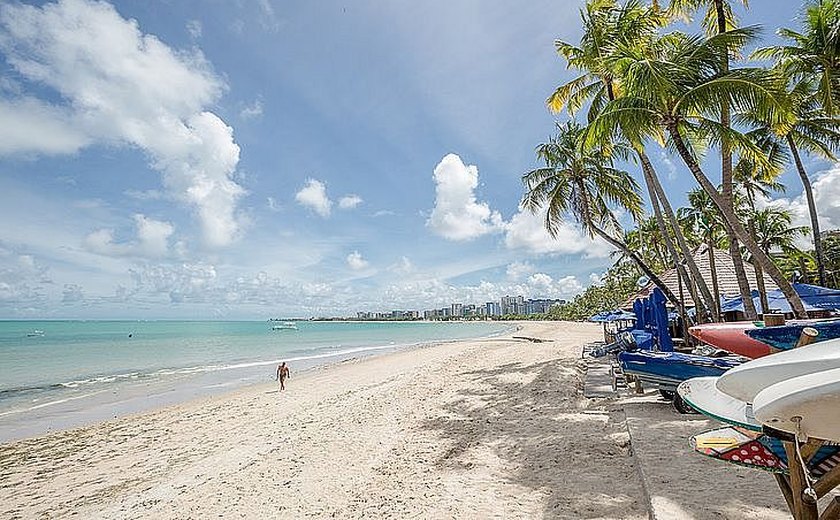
[667,0,756,319]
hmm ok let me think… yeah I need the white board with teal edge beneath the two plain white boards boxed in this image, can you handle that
[677,377,761,432]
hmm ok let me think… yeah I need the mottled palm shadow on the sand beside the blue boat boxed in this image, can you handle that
[424,359,647,518]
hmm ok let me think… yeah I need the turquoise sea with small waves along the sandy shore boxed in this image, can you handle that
[0,321,510,441]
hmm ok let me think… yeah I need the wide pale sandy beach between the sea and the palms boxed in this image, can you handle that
[0,322,788,519]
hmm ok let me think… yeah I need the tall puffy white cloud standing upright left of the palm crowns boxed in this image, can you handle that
[426,154,502,241]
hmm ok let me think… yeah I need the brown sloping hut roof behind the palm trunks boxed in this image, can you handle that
[625,244,778,308]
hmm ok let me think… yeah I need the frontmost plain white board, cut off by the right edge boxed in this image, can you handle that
[753,368,840,442]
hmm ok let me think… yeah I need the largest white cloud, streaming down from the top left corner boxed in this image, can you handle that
[0,0,245,246]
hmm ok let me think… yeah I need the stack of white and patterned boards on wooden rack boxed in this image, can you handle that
[677,339,840,477]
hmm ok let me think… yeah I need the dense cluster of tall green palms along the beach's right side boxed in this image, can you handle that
[523,0,840,321]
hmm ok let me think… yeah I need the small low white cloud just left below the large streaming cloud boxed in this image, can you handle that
[84,214,175,258]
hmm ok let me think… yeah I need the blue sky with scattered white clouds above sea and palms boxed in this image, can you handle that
[0,0,840,319]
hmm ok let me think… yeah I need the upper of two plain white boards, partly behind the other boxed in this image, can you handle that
[716,338,840,403]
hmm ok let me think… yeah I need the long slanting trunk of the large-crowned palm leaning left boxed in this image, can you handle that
[666,122,808,319]
